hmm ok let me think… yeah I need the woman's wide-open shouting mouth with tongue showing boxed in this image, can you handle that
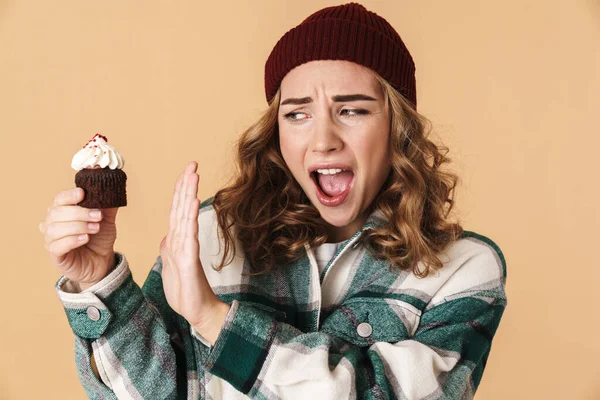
[310,168,354,207]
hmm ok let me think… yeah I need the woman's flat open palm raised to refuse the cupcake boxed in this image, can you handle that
[160,161,221,327]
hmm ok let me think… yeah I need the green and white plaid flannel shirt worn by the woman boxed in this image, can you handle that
[56,201,506,399]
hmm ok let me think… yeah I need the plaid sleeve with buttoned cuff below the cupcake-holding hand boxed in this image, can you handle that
[55,253,193,399]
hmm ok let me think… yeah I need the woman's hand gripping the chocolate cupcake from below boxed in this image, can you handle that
[39,188,118,289]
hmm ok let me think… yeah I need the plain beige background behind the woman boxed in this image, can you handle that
[0,0,600,400]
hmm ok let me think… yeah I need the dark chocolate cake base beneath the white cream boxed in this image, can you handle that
[75,167,127,208]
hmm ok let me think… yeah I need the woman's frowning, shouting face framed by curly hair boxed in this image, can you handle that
[277,60,390,242]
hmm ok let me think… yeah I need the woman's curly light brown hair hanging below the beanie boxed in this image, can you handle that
[212,72,463,277]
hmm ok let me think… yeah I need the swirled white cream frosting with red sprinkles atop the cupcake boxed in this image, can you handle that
[71,133,124,171]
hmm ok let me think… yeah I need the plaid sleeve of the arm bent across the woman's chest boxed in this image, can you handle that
[198,242,506,399]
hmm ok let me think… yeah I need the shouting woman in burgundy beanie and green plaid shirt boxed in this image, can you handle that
[41,3,506,399]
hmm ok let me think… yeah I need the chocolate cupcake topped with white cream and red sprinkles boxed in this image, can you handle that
[71,133,127,208]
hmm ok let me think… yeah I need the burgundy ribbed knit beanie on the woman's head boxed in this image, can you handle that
[265,3,417,109]
